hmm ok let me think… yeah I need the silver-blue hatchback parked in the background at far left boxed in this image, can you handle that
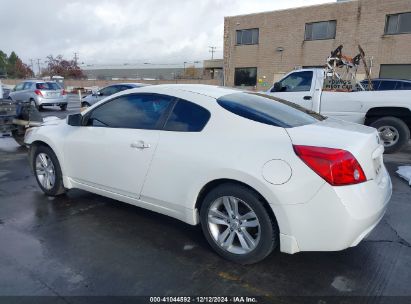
[9,80,68,111]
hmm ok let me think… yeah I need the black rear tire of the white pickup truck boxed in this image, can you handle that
[370,116,410,154]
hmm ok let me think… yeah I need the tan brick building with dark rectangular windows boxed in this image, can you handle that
[224,0,411,90]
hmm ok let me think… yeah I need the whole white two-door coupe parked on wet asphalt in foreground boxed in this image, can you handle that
[25,85,392,264]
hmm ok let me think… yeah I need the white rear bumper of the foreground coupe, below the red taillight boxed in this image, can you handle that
[272,168,392,254]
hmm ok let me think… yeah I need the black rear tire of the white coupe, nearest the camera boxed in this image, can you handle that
[200,183,279,265]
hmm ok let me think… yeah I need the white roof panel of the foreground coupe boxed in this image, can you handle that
[129,84,244,99]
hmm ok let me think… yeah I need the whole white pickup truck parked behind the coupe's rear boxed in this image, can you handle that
[265,69,411,153]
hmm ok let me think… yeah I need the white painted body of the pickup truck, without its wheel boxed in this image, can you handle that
[266,69,411,151]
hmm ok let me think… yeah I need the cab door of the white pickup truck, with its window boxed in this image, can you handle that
[269,71,315,110]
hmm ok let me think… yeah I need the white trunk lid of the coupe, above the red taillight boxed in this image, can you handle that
[286,118,384,183]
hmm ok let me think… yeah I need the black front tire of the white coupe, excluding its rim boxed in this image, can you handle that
[30,145,66,196]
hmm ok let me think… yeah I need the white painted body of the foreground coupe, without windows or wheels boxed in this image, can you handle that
[25,85,391,254]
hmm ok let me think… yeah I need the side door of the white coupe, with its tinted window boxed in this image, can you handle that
[64,93,172,199]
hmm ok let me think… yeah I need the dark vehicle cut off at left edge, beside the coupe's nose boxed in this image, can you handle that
[0,99,43,146]
